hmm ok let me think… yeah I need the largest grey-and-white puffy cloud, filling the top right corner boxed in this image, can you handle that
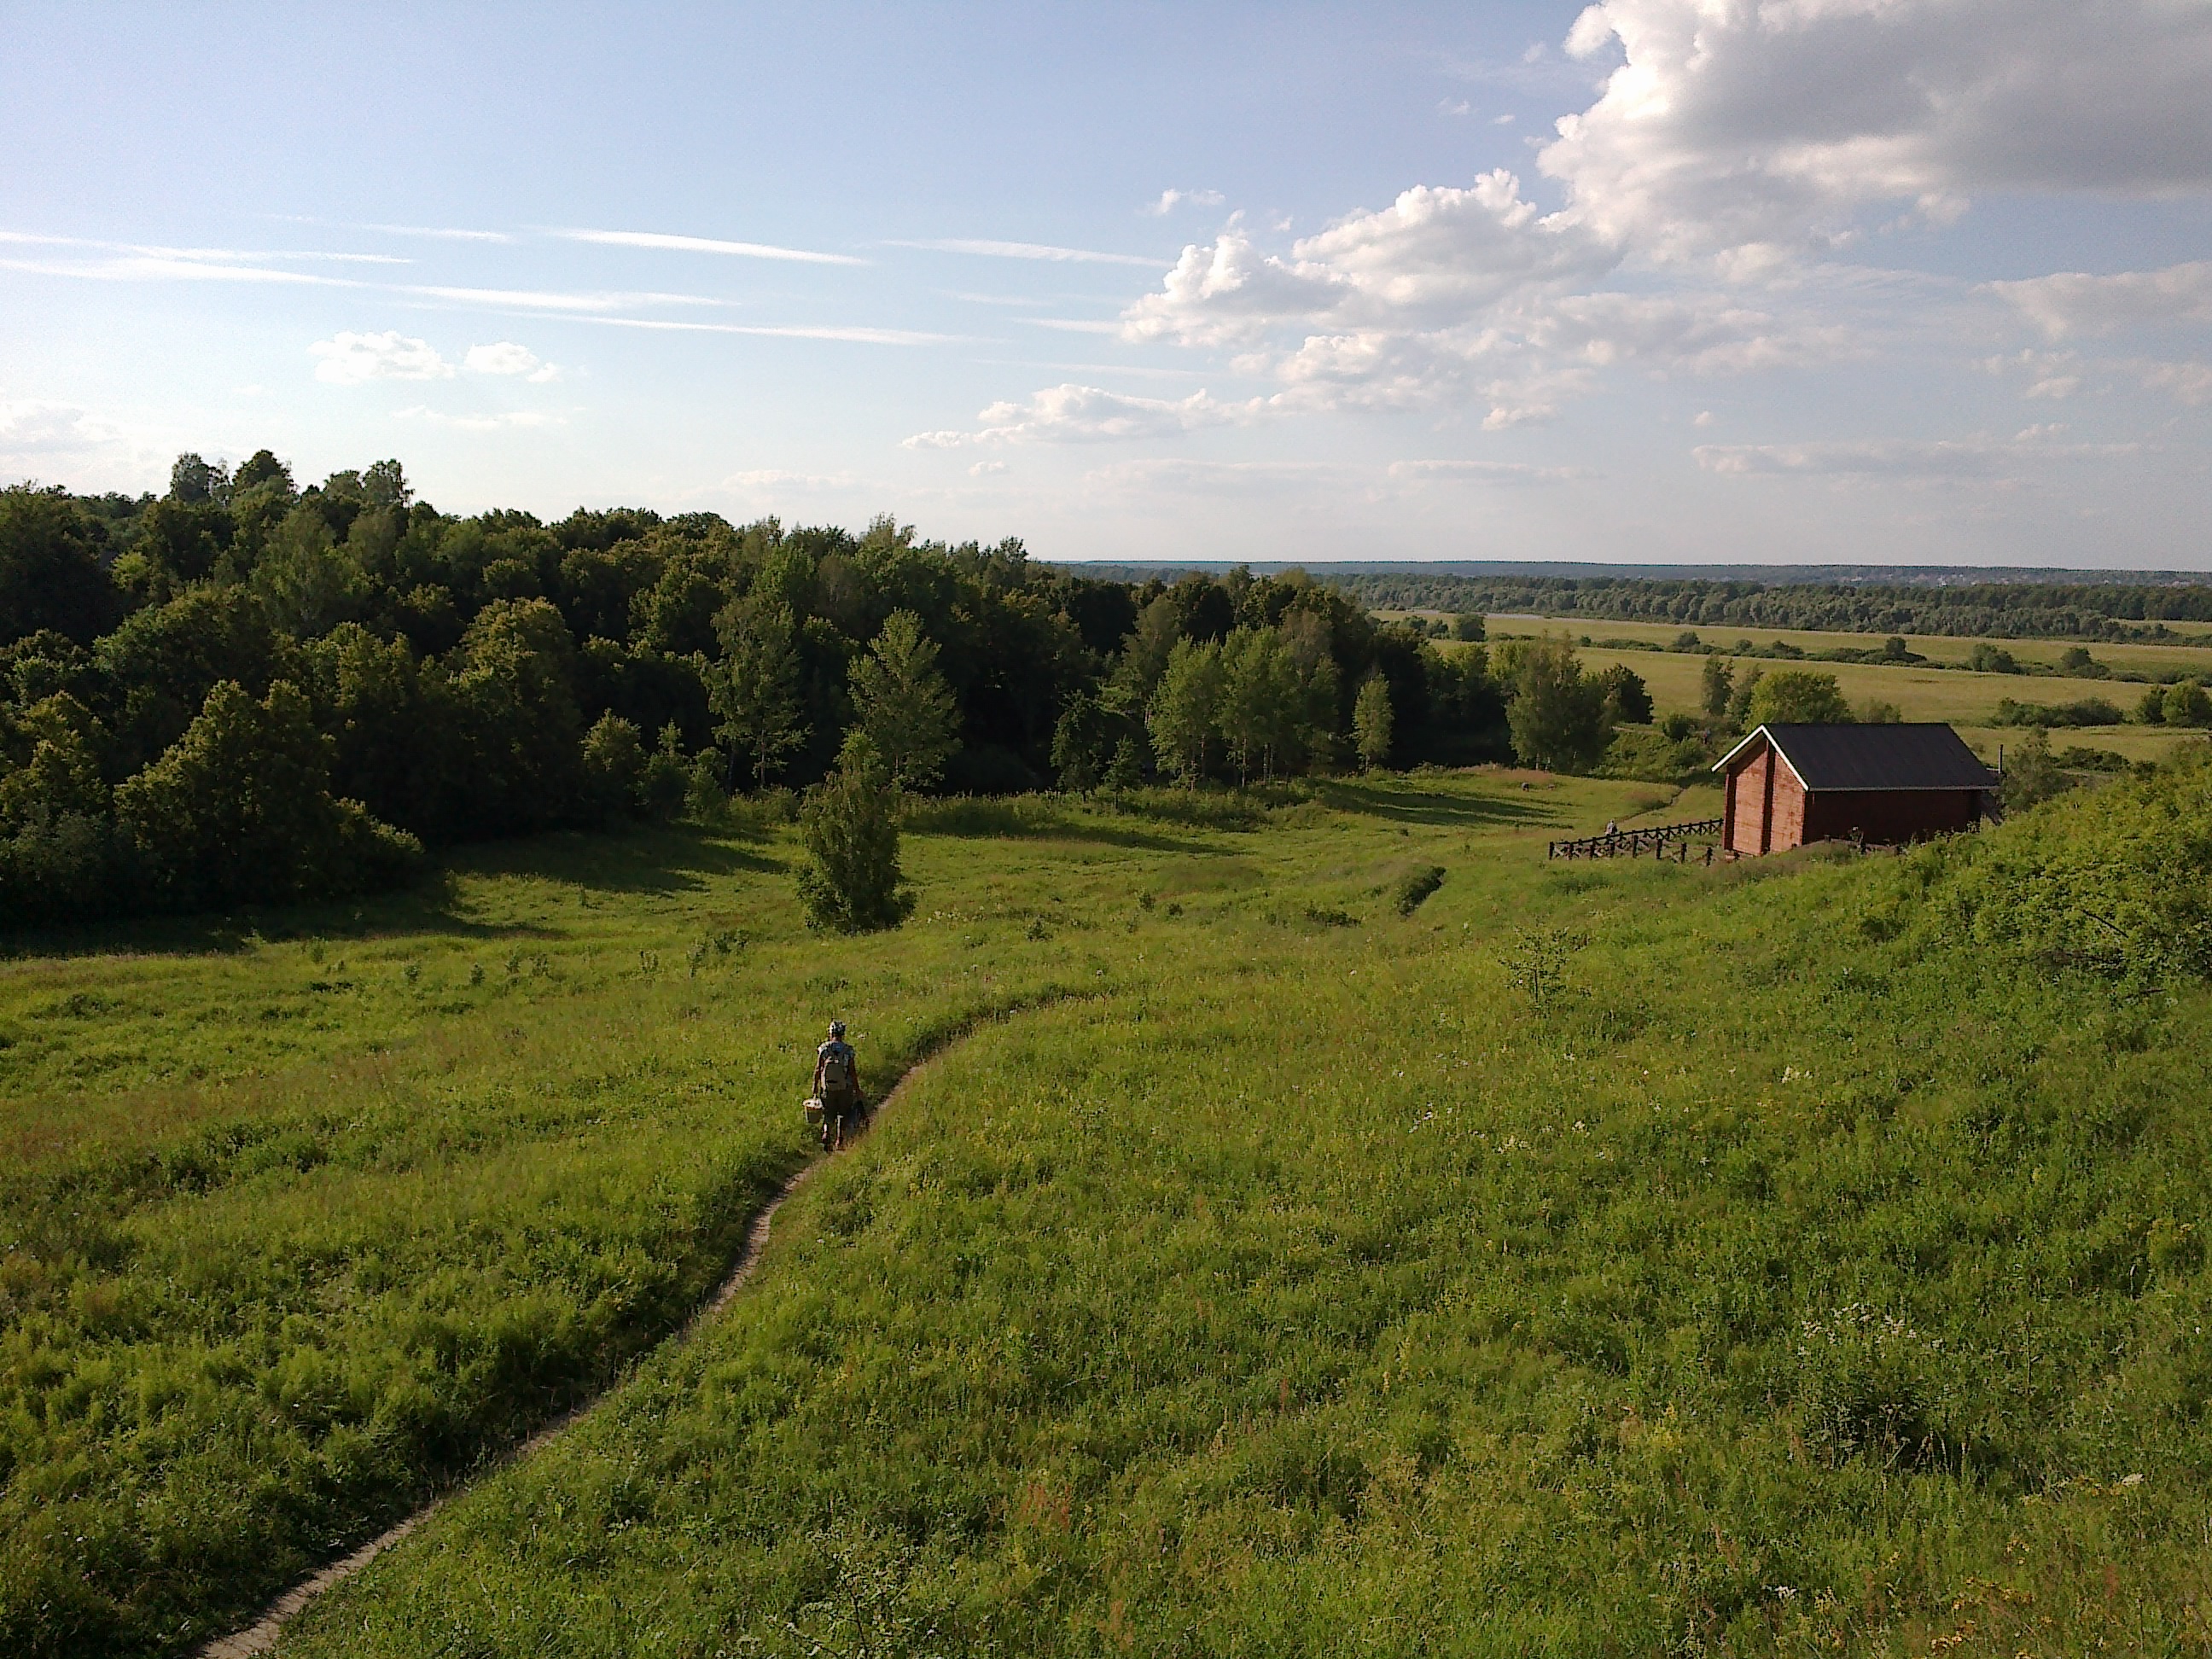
[1540,0,2212,257]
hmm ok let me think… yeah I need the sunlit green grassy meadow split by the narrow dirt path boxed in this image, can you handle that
[0,772,2212,1659]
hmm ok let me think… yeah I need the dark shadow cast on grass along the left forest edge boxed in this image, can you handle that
[0,827,783,960]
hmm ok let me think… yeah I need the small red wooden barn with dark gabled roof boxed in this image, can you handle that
[1712,725,1998,856]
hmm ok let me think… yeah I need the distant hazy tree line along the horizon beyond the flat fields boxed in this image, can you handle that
[1320,571,2212,639]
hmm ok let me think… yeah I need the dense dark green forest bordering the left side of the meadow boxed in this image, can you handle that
[0,451,1530,924]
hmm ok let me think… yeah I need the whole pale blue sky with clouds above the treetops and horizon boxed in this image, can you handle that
[0,0,2212,571]
